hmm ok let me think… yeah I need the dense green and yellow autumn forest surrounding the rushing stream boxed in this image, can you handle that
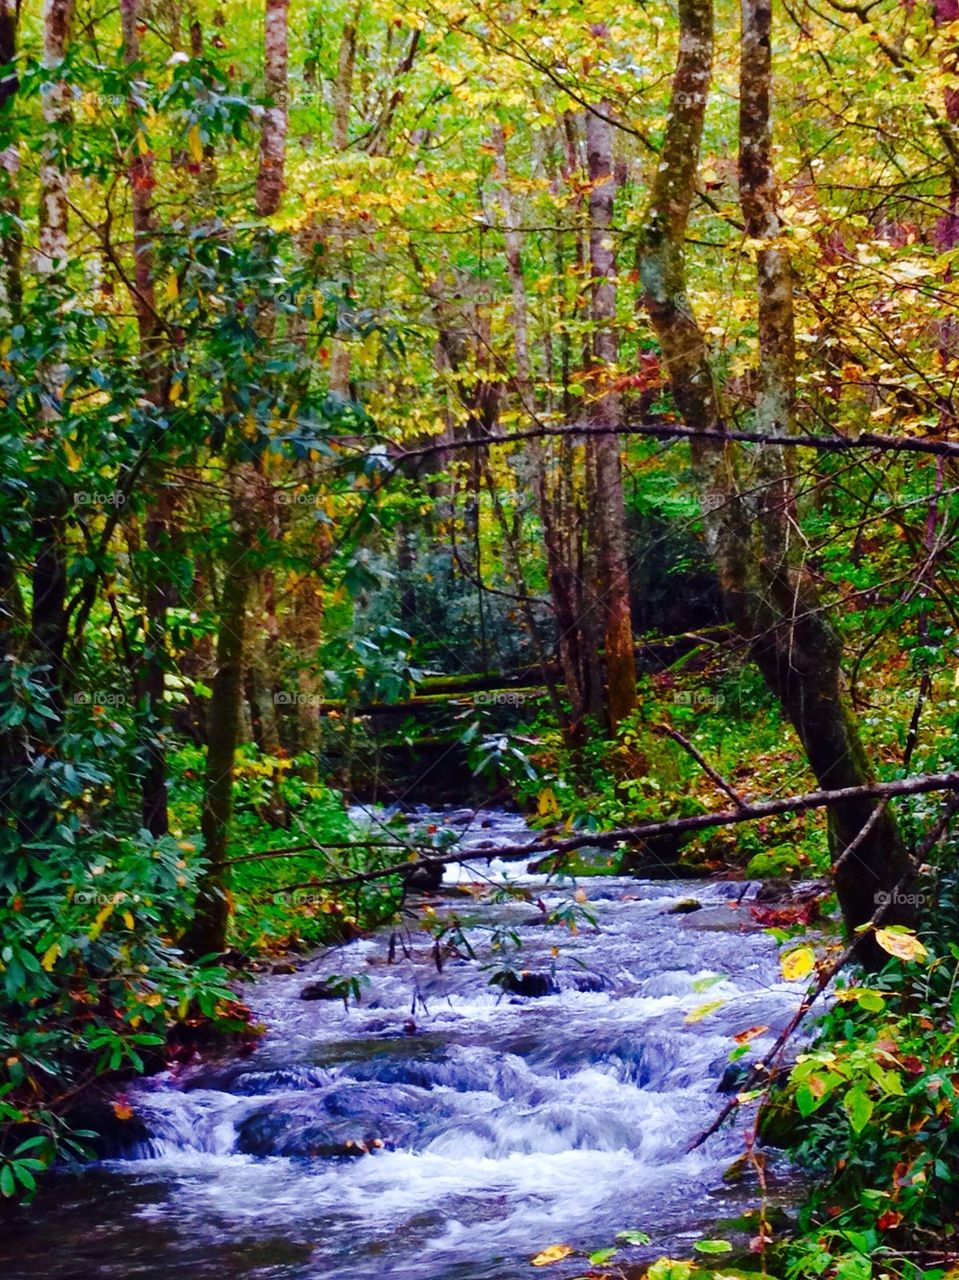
[0,0,959,1280]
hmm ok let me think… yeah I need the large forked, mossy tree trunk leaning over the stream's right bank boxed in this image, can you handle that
[639,0,908,964]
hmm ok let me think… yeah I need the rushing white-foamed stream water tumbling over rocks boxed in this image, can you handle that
[0,810,799,1280]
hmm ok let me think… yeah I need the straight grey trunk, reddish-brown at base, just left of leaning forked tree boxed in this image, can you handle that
[586,102,636,731]
